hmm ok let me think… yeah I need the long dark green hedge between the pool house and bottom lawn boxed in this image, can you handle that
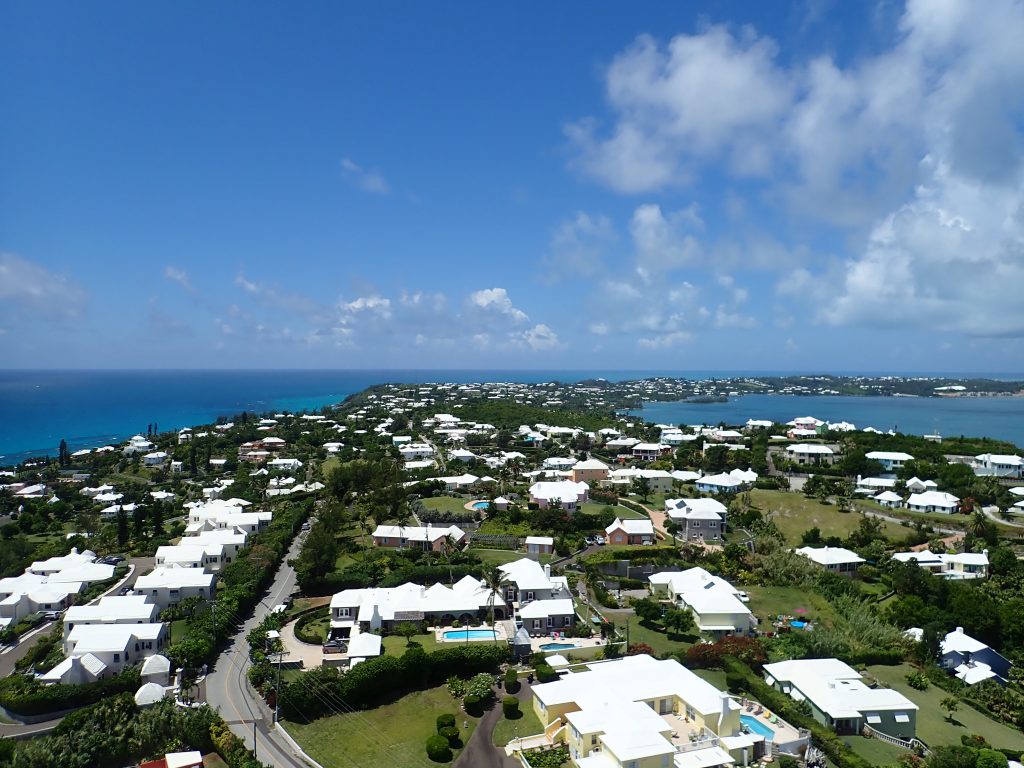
[281,643,512,721]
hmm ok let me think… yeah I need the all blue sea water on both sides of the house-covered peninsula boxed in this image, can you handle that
[0,370,1024,465]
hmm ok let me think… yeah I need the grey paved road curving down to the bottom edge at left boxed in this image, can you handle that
[199,536,308,768]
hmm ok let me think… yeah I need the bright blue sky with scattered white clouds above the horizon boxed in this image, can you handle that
[0,0,1024,372]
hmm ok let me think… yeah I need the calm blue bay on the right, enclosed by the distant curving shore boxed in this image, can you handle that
[630,394,1024,446]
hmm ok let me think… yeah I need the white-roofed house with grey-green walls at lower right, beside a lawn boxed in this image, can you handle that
[764,658,918,739]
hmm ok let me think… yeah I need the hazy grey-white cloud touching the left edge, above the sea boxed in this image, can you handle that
[0,253,86,323]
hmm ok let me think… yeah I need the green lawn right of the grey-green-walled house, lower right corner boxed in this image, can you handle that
[867,664,1024,750]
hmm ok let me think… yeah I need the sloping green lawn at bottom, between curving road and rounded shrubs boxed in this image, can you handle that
[287,686,479,768]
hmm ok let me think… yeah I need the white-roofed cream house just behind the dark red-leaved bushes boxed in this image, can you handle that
[648,567,754,638]
